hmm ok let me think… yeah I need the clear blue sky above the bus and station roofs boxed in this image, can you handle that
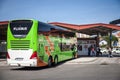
[0,0,120,24]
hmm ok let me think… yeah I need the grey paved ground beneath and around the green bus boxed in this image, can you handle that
[0,56,120,80]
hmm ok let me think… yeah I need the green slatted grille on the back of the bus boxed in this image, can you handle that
[11,40,30,49]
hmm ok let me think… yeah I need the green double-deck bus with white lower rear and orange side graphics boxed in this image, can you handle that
[7,19,76,67]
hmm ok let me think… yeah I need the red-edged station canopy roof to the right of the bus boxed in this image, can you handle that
[50,22,120,35]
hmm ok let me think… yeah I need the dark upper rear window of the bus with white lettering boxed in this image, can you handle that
[10,20,33,38]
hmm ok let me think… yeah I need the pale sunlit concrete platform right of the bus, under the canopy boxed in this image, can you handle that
[65,57,120,64]
